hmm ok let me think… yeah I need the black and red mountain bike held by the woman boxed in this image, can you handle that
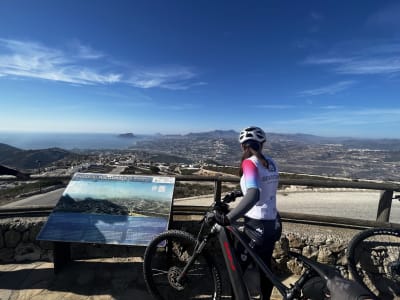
[143,194,372,300]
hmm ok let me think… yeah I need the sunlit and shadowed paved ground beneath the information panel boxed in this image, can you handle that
[0,258,293,300]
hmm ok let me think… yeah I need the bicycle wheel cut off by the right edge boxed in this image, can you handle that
[346,228,400,299]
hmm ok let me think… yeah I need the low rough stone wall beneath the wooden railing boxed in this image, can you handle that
[0,218,354,275]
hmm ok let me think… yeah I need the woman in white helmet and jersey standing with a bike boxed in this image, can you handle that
[209,126,282,300]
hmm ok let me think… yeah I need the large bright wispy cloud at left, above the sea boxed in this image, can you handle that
[0,39,205,90]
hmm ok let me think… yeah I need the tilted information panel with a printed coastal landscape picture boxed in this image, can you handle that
[37,173,175,246]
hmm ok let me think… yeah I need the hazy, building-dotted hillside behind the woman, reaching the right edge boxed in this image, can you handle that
[135,130,400,181]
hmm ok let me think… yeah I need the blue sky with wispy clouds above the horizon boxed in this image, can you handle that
[0,0,400,138]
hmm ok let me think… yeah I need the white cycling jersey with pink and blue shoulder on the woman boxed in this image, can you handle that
[240,155,279,220]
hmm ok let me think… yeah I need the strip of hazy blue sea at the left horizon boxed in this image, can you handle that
[0,131,151,150]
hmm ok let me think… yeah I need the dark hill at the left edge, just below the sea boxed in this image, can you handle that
[0,143,76,170]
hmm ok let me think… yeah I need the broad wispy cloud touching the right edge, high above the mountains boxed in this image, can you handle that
[304,41,400,75]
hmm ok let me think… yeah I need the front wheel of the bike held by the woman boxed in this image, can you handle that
[143,230,222,300]
